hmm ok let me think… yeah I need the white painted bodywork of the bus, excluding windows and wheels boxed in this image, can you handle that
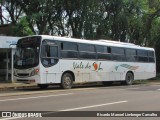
[15,35,156,84]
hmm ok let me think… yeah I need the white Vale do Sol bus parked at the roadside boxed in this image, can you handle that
[14,35,156,89]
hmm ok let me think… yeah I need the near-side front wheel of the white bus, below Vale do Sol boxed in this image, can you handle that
[61,73,73,89]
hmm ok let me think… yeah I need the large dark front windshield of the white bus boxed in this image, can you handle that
[14,37,41,68]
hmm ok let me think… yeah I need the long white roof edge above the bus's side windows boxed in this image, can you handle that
[23,35,154,51]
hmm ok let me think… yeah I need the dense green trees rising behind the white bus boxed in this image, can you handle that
[0,0,160,44]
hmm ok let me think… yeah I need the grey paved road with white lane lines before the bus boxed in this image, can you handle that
[0,85,160,120]
